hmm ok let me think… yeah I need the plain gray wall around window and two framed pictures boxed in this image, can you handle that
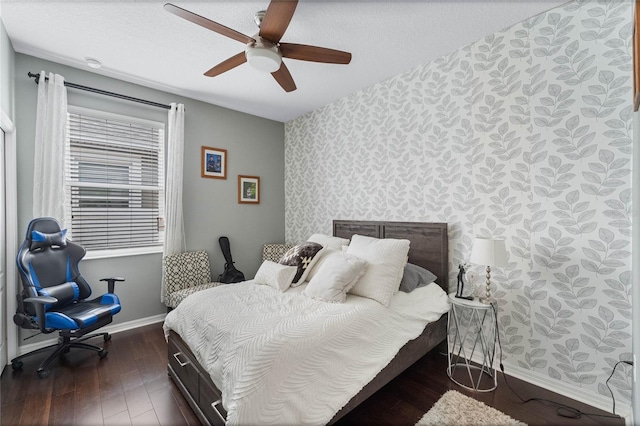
[15,54,284,334]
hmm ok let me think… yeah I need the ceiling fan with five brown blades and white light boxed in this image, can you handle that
[164,0,351,92]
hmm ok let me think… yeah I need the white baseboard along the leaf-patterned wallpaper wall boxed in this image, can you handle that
[464,352,632,425]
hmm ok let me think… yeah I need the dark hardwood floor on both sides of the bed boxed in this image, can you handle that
[0,324,624,426]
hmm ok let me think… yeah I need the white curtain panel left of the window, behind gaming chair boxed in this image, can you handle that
[33,71,67,225]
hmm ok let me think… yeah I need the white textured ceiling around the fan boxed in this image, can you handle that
[0,0,565,122]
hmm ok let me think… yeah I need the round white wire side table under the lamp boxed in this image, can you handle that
[447,293,498,392]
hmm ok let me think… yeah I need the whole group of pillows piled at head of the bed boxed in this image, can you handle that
[255,234,424,306]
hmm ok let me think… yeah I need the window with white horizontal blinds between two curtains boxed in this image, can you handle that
[66,107,164,254]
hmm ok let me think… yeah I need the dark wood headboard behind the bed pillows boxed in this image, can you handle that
[333,220,449,293]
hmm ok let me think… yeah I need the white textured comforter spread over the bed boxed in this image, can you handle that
[164,281,449,425]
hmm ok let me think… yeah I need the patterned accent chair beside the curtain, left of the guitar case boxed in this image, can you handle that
[162,250,222,309]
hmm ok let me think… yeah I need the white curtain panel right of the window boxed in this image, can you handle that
[160,103,186,302]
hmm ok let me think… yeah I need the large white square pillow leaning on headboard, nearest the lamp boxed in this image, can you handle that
[347,235,409,306]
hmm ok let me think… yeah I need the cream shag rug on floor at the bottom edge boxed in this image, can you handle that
[416,390,527,426]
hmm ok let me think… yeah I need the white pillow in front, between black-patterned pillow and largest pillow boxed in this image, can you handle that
[302,250,367,303]
